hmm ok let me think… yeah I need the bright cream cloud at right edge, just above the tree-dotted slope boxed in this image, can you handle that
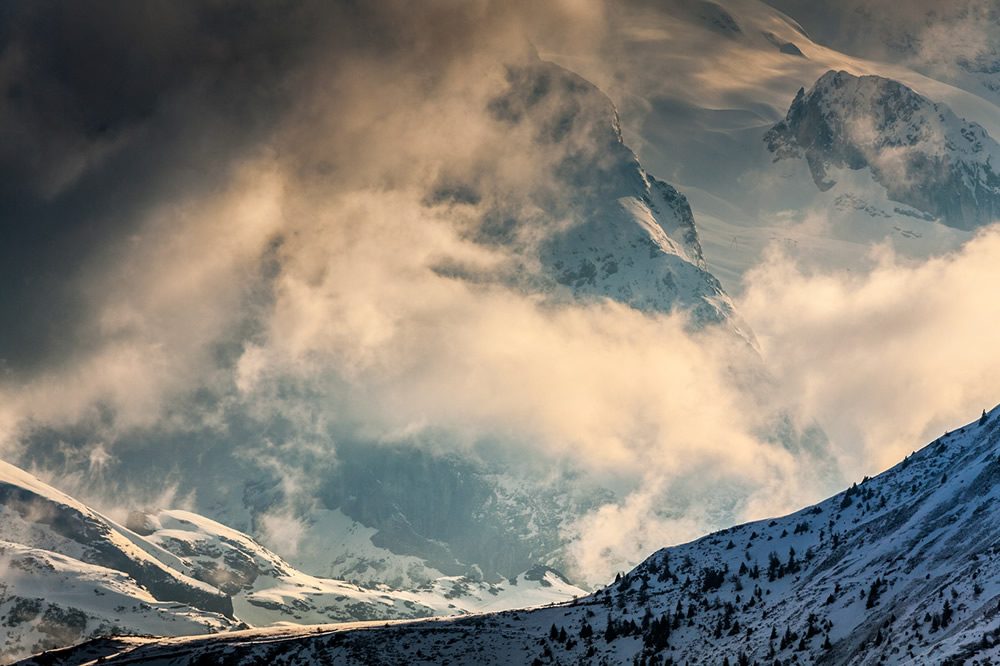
[740,226,1000,476]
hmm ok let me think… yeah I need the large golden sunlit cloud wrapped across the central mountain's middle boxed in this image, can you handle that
[5,153,836,583]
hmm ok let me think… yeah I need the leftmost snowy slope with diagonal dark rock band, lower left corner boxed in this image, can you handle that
[0,462,240,662]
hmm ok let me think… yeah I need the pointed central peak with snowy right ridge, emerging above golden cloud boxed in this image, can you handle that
[458,53,752,341]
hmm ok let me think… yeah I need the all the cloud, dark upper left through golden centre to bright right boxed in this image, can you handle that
[0,0,1000,581]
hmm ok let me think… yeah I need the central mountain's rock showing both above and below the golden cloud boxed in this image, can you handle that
[290,58,753,584]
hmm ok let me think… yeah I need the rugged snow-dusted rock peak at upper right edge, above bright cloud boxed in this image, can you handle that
[764,70,1000,230]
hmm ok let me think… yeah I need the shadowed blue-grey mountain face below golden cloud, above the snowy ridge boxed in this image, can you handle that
[319,444,613,583]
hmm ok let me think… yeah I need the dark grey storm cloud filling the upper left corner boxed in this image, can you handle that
[0,2,320,369]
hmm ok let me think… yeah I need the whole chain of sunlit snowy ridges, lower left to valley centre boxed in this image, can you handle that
[0,462,584,663]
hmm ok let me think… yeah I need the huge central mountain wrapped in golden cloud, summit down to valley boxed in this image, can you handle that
[0,0,836,596]
